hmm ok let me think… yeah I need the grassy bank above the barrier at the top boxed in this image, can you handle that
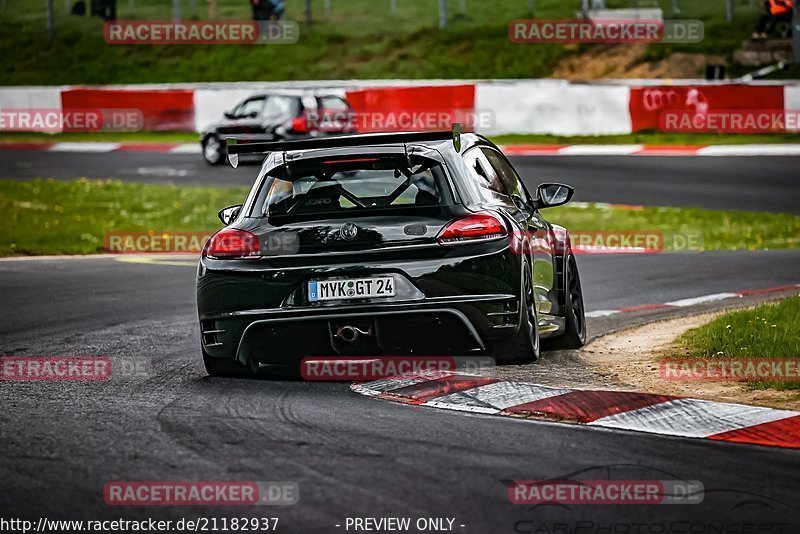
[0,0,798,85]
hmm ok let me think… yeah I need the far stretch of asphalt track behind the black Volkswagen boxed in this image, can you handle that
[0,150,800,213]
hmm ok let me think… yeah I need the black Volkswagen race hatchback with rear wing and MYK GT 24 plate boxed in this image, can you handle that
[197,132,586,375]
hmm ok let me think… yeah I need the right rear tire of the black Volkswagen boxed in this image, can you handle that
[487,263,540,365]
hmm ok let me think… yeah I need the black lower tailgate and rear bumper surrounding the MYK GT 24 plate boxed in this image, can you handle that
[197,243,521,364]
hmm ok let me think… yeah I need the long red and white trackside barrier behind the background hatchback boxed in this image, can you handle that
[0,80,800,136]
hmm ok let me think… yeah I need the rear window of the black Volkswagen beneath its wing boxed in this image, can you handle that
[256,155,447,218]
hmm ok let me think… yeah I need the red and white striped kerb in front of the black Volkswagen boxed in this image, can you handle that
[351,371,800,448]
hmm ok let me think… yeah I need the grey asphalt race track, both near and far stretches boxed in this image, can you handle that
[0,152,800,534]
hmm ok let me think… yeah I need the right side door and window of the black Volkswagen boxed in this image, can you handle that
[481,147,558,314]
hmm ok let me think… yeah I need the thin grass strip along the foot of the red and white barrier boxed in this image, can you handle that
[0,132,800,145]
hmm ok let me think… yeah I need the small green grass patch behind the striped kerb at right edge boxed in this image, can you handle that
[673,294,800,389]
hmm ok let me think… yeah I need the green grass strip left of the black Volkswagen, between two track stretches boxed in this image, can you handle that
[0,179,248,256]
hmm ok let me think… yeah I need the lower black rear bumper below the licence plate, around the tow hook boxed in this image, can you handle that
[200,294,519,364]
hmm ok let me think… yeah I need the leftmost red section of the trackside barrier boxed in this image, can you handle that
[61,89,194,131]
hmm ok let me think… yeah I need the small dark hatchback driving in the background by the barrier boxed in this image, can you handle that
[200,91,355,165]
